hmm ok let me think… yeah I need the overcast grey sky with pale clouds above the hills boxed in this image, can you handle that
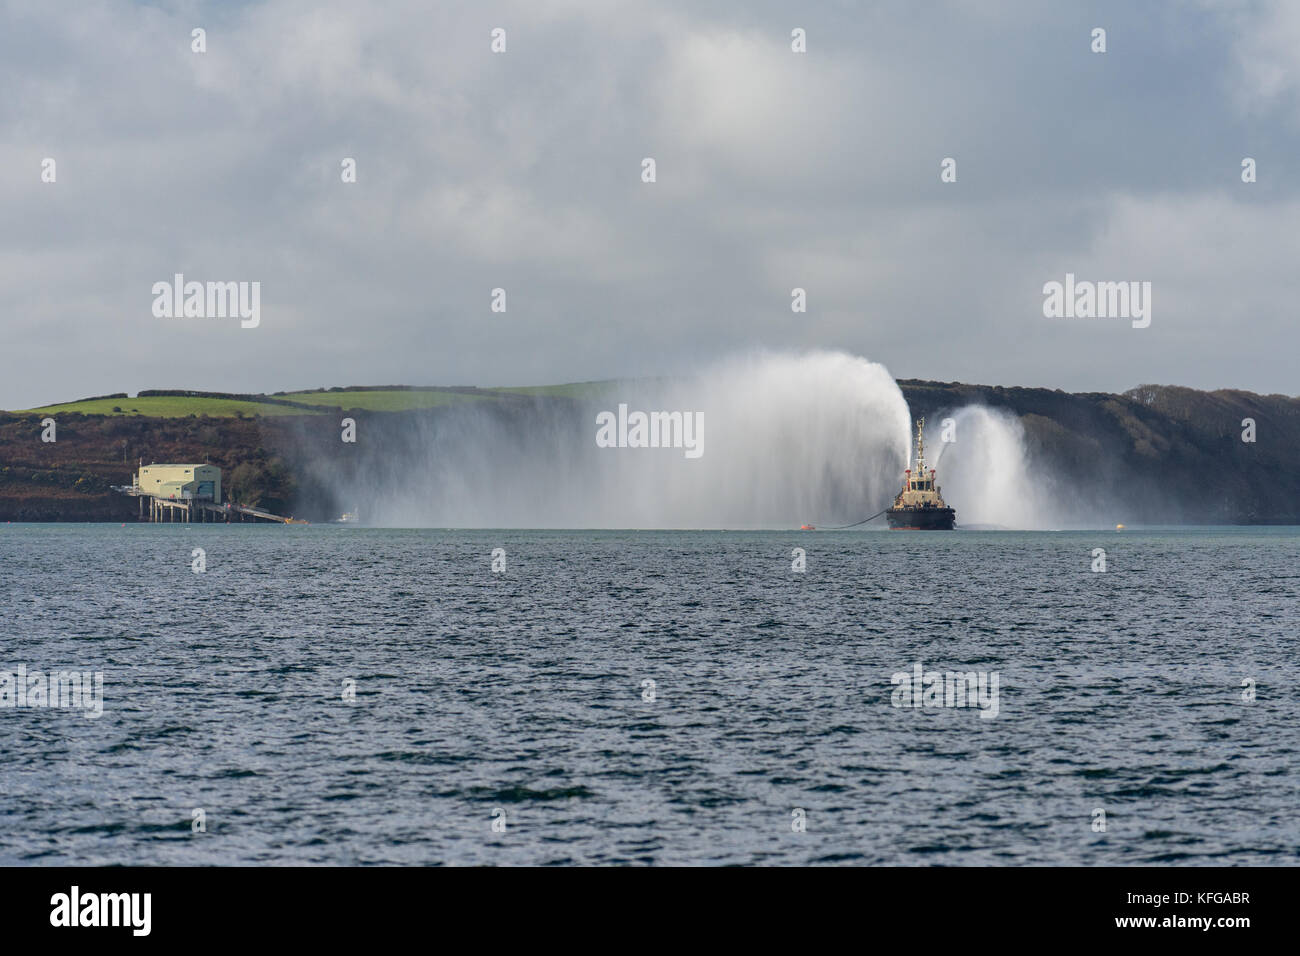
[0,0,1300,408]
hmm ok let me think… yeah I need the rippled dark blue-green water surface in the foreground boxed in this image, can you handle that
[0,524,1300,865]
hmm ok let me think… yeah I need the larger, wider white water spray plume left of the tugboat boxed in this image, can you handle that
[327,351,909,528]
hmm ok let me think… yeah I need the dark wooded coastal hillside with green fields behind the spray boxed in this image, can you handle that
[0,380,1300,524]
